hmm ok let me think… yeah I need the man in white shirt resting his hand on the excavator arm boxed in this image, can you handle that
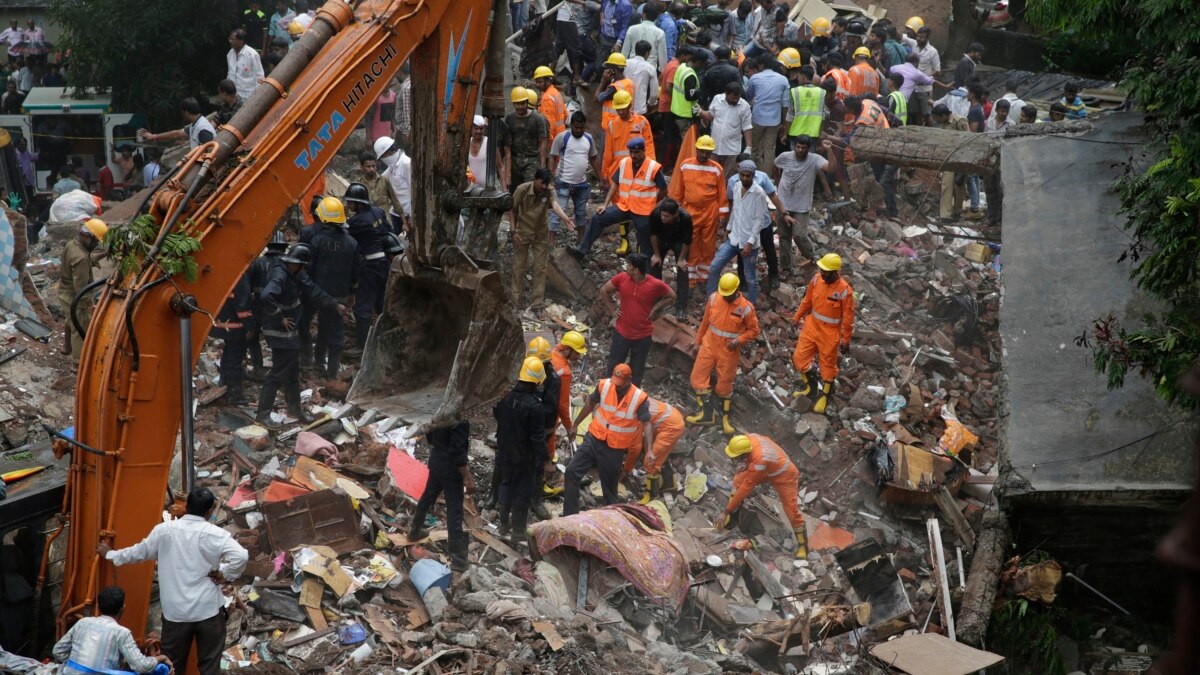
[96,488,250,675]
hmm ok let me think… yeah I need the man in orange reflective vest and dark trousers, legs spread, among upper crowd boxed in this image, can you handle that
[568,137,667,261]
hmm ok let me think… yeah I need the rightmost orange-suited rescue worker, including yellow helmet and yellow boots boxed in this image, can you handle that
[792,253,854,414]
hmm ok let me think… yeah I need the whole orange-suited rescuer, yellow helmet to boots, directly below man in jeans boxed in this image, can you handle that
[688,271,758,436]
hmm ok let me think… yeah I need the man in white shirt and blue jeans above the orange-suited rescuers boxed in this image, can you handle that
[707,160,769,303]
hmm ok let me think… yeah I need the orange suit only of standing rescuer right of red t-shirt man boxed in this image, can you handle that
[691,292,758,399]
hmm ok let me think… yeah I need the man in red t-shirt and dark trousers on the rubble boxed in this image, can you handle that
[600,253,676,386]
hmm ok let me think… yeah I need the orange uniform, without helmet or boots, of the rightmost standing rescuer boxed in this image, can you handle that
[792,274,854,382]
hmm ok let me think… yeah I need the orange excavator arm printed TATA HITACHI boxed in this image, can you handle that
[58,0,521,648]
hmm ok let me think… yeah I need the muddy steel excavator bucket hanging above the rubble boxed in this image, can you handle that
[349,247,524,432]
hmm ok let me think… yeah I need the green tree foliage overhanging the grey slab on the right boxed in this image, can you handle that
[1026,0,1200,408]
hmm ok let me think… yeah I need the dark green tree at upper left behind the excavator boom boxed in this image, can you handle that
[47,0,238,129]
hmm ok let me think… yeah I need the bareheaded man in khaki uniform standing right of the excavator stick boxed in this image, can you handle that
[509,167,575,307]
